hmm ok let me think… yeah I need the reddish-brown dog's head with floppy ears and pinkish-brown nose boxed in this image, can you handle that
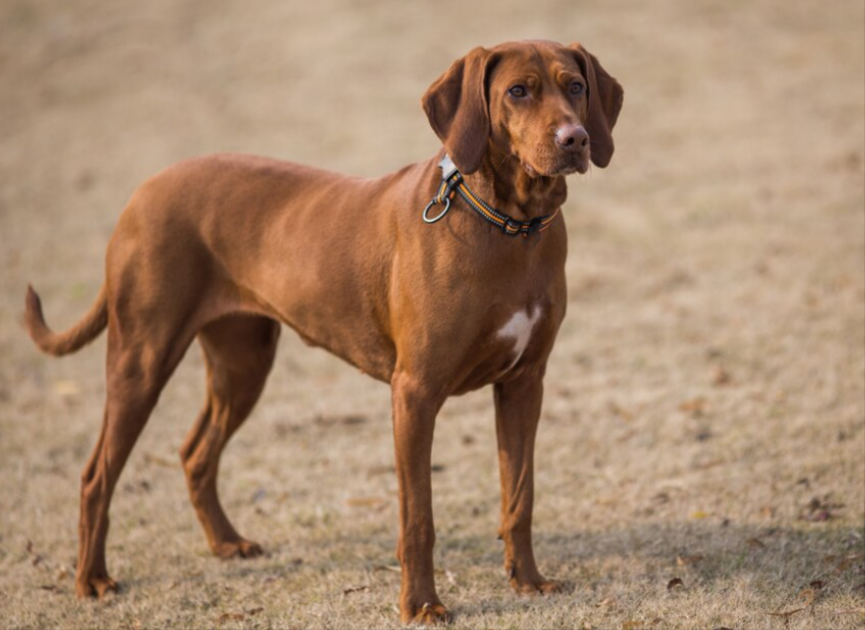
[421,41,624,177]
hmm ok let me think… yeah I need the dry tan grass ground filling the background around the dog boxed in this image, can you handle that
[0,0,865,628]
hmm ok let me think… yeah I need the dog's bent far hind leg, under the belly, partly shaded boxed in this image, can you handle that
[180,316,279,558]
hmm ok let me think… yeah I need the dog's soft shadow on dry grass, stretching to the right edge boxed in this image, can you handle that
[204,522,865,595]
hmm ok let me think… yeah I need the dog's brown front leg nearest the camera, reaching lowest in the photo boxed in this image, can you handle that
[391,373,449,625]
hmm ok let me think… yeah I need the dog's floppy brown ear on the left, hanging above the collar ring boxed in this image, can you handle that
[421,47,492,175]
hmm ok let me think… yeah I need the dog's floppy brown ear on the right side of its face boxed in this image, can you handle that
[569,44,625,168]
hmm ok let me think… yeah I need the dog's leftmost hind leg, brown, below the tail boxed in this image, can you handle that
[75,324,188,597]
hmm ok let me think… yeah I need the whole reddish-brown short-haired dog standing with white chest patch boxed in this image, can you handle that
[26,41,623,623]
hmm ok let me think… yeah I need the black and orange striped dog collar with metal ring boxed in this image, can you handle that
[423,153,561,236]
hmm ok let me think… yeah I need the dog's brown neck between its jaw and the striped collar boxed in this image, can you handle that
[465,147,568,221]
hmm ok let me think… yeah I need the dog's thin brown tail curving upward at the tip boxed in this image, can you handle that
[24,285,108,357]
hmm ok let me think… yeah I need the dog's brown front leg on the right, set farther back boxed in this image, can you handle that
[494,375,560,593]
